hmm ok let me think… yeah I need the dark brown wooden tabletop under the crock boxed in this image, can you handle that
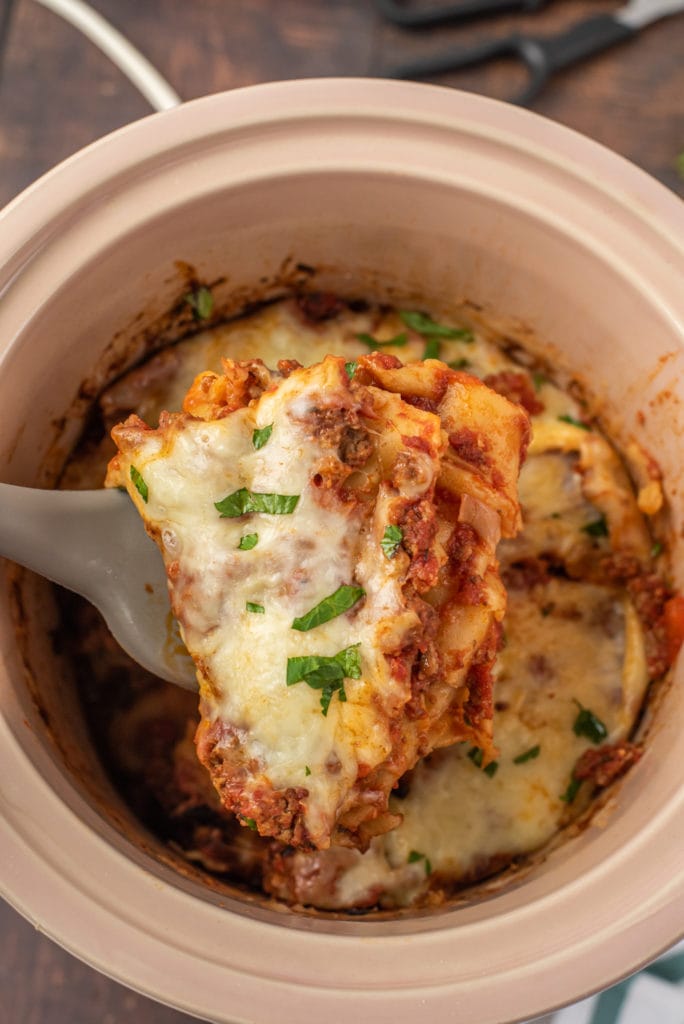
[0,0,684,1024]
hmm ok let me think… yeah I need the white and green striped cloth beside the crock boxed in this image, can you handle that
[529,942,684,1024]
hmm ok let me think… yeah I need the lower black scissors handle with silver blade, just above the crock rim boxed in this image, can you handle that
[384,0,684,106]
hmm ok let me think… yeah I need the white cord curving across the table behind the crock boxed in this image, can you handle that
[37,0,181,111]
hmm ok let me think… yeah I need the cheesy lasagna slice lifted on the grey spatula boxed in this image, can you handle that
[106,353,528,849]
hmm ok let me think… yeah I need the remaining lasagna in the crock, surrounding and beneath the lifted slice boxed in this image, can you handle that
[59,295,684,913]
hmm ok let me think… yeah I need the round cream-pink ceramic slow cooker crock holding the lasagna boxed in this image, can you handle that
[0,80,684,1024]
